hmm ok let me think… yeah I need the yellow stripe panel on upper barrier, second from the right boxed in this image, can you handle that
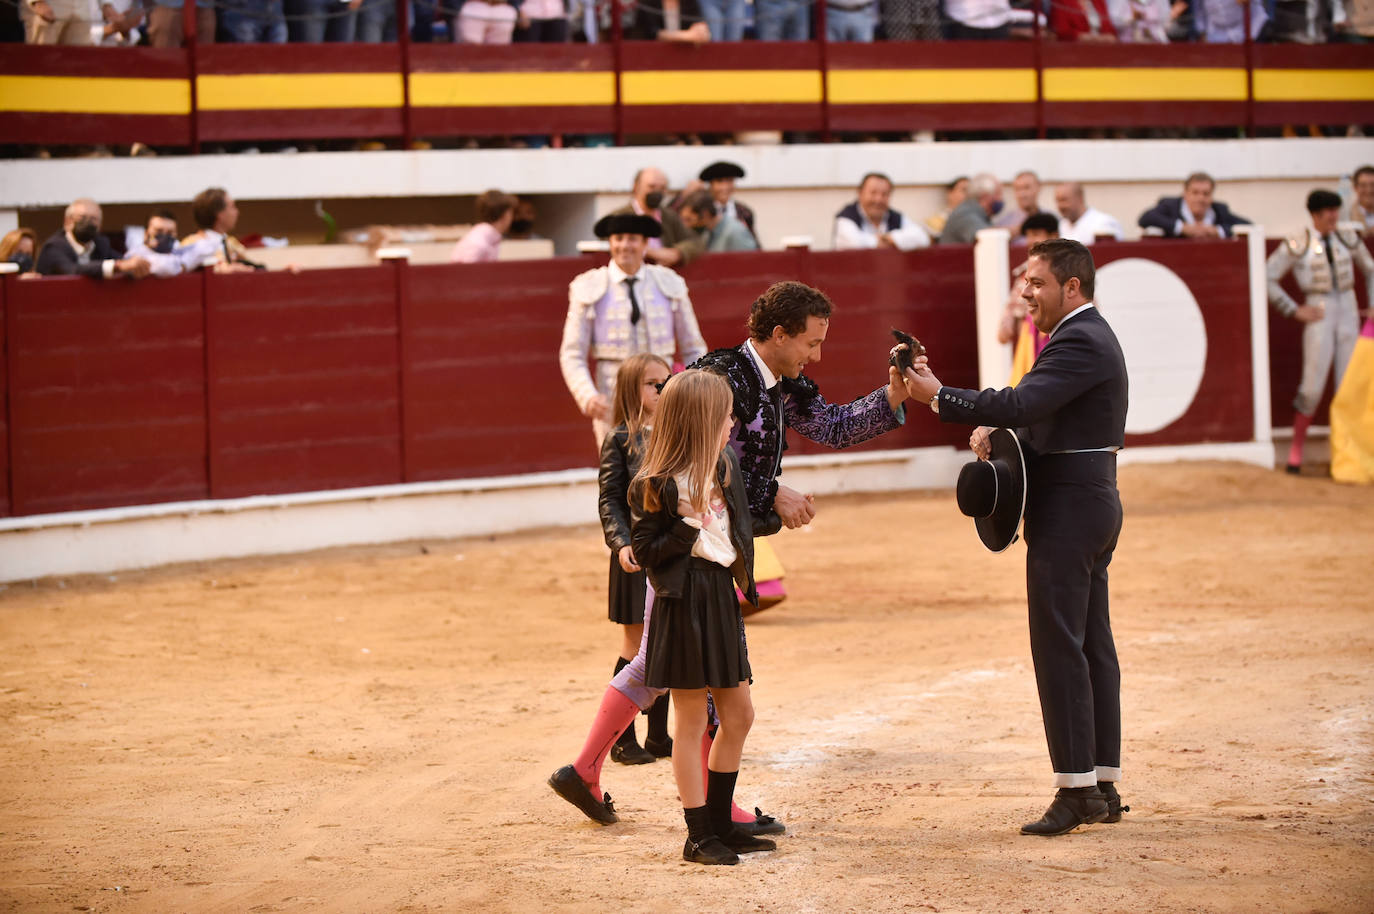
[1044,67,1245,102]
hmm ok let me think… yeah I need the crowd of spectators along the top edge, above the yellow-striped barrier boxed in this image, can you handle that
[0,0,1374,48]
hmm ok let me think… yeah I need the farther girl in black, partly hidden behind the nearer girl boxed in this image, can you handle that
[598,352,672,764]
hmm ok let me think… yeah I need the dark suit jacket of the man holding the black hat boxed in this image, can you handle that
[940,308,1128,456]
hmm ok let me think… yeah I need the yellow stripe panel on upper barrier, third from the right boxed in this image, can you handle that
[830,69,1035,104]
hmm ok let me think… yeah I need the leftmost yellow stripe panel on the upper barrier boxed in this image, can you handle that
[0,76,191,115]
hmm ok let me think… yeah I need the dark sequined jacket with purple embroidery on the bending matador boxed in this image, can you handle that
[688,344,905,536]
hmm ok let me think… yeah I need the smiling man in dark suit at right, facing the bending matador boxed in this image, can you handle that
[905,238,1127,836]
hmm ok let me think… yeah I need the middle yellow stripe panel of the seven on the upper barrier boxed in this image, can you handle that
[621,70,822,104]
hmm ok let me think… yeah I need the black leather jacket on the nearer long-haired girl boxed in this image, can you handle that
[629,447,758,606]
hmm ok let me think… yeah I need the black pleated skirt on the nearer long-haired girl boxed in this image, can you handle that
[644,558,750,689]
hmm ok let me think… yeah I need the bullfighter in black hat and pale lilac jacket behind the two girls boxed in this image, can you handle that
[558,212,706,447]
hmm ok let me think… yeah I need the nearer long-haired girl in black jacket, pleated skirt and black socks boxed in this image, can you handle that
[629,370,776,865]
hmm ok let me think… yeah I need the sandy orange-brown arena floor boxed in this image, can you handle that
[0,465,1374,914]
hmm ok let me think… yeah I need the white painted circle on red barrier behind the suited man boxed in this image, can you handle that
[1095,257,1206,434]
